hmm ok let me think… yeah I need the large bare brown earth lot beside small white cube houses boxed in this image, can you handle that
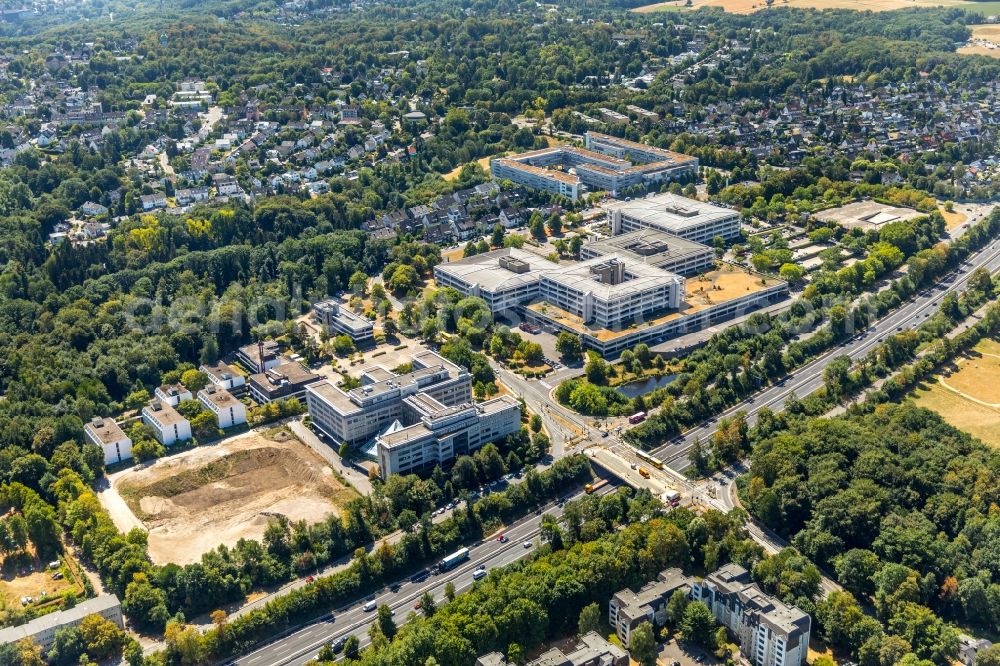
[100,429,357,564]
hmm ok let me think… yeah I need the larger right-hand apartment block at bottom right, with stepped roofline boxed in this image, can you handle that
[691,564,811,666]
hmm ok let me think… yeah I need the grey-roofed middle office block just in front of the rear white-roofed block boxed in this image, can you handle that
[580,229,715,275]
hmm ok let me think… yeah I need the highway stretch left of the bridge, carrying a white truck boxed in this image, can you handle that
[228,482,616,666]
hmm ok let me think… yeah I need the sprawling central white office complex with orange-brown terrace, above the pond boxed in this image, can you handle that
[434,194,788,355]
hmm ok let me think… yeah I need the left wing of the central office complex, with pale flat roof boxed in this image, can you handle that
[434,248,559,314]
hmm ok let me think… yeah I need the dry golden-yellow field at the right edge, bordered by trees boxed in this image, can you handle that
[912,340,1000,447]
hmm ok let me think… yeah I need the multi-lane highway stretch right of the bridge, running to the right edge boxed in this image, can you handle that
[651,236,1000,471]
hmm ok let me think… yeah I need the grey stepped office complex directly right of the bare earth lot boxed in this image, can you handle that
[306,351,521,478]
